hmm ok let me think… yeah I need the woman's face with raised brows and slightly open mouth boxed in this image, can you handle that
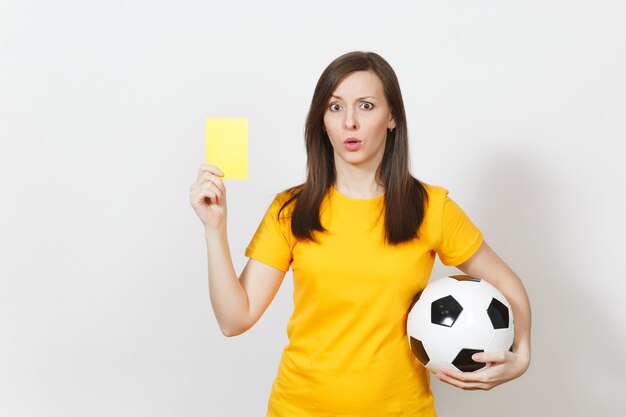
[324,71,395,170]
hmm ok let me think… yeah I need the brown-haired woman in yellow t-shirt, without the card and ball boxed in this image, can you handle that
[190,52,530,417]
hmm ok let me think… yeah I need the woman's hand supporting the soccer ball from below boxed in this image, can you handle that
[435,352,530,391]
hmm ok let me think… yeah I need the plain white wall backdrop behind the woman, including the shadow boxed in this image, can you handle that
[0,0,626,417]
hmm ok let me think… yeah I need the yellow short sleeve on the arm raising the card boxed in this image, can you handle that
[245,194,294,272]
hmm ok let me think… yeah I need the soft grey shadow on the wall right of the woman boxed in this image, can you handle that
[432,148,626,417]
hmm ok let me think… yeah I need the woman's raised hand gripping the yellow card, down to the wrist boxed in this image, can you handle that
[189,164,226,230]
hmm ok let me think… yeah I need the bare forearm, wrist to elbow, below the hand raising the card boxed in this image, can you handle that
[205,226,249,336]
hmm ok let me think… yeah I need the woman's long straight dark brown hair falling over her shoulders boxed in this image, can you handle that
[278,51,428,244]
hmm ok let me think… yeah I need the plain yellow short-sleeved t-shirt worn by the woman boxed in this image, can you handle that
[241,184,482,417]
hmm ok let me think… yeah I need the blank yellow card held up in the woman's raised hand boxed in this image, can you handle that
[206,117,248,180]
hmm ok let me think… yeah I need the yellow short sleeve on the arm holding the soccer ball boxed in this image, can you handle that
[435,193,483,266]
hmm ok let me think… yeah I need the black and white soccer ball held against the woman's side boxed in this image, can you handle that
[407,275,514,372]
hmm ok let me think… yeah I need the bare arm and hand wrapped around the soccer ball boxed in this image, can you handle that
[437,242,531,390]
